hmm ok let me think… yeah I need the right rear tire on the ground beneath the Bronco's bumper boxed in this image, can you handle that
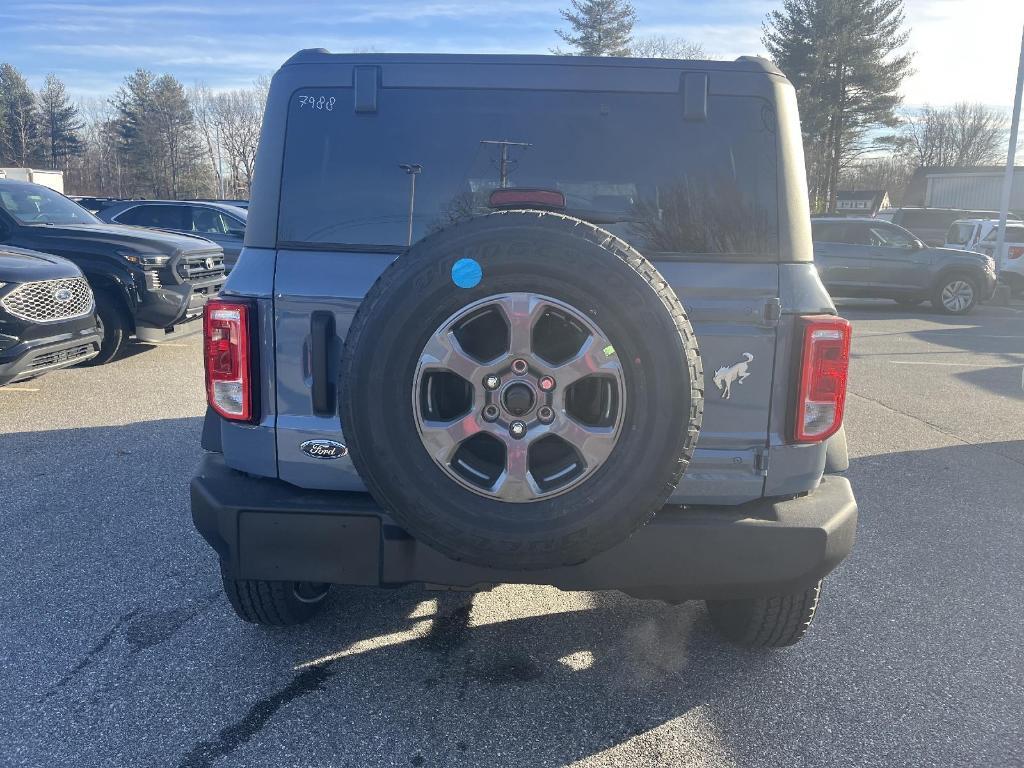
[707,582,821,648]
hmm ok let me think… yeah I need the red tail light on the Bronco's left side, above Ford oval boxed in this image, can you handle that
[203,300,255,421]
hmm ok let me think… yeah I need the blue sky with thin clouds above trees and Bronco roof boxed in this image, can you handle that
[0,0,1024,110]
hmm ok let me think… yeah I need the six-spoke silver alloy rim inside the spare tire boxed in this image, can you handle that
[413,293,626,503]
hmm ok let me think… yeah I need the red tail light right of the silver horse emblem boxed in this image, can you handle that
[793,314,851,442]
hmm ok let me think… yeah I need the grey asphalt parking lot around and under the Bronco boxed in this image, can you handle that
[0,302,1024,768]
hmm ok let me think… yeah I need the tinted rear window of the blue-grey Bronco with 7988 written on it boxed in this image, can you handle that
[279,88,778,255]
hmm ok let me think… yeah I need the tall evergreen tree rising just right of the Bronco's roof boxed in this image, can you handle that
[762,0,912,211]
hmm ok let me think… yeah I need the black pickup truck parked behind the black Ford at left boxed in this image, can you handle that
[0,179,224,364]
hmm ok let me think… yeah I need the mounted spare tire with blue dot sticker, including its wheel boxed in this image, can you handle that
[341,211,703,570]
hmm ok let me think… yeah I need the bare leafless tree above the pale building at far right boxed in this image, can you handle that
[903,101,1008,168]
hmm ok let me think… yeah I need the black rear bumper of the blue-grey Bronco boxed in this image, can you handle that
[191,454,857,600]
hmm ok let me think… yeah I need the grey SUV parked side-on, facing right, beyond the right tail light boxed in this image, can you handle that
[811,216,995,314]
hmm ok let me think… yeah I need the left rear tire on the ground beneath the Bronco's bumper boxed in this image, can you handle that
[220,565,331,627]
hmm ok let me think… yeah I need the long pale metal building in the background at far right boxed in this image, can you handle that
[903,165,1024,213]
